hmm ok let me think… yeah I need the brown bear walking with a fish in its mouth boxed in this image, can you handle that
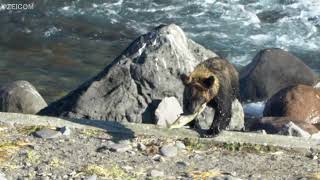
[182,57,239,135]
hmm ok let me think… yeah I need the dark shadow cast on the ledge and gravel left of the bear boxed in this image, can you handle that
[66,119,134,142]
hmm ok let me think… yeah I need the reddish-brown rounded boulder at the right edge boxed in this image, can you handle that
[263,85,320,124]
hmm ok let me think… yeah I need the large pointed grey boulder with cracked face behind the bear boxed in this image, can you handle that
[39,24,217,123]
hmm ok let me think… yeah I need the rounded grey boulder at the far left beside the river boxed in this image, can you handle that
[0,81,47,114]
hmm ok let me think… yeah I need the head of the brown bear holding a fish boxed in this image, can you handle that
[181,72,219,113]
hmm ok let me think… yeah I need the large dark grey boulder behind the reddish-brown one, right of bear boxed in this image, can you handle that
[240,49,317,101]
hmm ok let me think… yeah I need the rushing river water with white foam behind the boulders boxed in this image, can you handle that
[0,0,320,102]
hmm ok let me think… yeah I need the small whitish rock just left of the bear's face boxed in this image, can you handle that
[155,97,183,127]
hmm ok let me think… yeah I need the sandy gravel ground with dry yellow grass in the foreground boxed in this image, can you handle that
[0,126,320,179]
